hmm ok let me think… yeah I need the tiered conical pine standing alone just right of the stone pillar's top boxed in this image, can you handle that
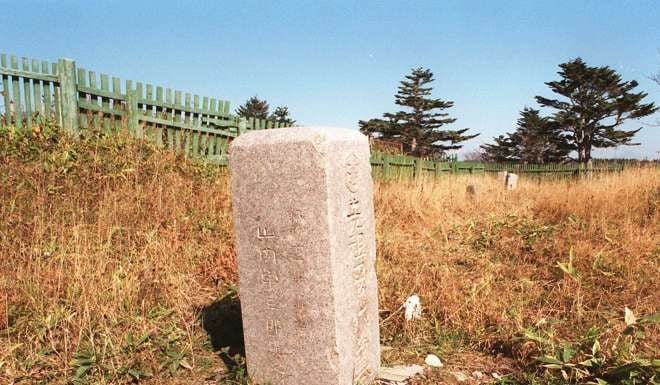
[359,68,479,157]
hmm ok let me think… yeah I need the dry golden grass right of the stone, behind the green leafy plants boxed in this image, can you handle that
[375,169,660,378]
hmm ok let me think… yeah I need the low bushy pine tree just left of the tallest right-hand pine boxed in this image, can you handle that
[481,108,573,163]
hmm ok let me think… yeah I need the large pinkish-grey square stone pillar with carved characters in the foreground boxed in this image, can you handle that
[230,127,380,385]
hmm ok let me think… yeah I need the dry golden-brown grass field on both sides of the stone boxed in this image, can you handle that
[0,128,660,385]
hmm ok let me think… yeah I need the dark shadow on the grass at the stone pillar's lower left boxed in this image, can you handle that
[200,295,245,371]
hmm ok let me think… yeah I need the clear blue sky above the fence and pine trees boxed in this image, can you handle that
[0,0,660,157]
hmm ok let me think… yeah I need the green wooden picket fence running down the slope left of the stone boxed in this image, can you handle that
[0,54,280,164]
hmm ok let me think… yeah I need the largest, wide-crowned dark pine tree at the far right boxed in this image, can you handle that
[536,58,658,163]
